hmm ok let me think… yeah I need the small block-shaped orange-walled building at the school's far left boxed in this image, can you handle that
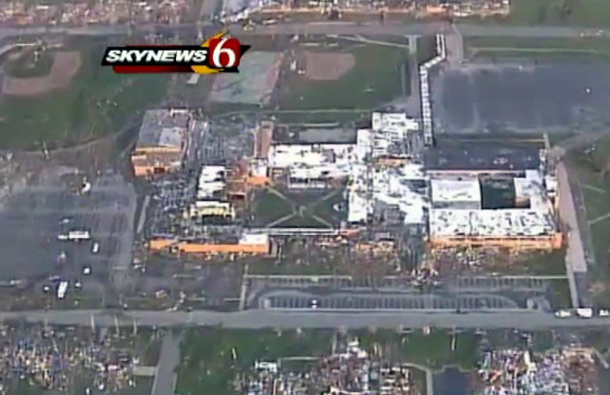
[131,109,192,177]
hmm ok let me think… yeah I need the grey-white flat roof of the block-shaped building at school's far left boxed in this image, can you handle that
[137,110,190,149]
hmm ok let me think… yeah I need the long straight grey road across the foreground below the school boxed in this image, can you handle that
[0,310,610,330]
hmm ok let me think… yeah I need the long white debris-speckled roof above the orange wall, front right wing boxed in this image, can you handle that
[430,209,556,238]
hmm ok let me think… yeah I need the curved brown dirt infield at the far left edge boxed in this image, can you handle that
[2,51,81,96]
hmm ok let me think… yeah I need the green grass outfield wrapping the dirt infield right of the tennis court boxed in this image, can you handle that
[279,44,409,110]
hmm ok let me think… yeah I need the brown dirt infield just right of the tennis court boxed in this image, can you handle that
[305,52,356,81]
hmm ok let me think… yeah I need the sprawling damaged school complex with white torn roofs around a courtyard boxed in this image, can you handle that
[134,112,563,255]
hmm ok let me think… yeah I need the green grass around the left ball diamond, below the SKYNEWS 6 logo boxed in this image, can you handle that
[0,38,170,149]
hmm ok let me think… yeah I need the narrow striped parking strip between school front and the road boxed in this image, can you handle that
[258,290,519,310]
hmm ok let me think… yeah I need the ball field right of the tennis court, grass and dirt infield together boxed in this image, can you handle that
[277,42,410,110]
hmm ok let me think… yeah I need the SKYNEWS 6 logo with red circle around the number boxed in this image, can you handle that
[102,32,250,74]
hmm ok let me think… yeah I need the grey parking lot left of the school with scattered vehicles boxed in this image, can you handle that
[0,169,136,298]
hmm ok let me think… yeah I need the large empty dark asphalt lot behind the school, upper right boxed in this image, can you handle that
[432,60,610,133]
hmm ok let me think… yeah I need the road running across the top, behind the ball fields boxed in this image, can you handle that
[0,22,610,39]
